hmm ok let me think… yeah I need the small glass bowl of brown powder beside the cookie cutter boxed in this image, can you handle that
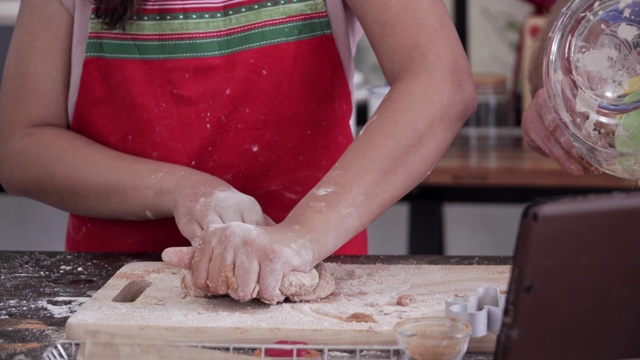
[393,317,472,360]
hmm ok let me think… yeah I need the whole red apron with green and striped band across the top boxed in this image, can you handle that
[66,0,367,254]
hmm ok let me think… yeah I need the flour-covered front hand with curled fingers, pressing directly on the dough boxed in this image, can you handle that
[163,222,316,304]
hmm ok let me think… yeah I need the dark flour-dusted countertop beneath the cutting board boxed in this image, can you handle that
[0,251,511,359]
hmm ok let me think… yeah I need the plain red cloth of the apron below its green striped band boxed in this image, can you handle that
[66,36,367,254]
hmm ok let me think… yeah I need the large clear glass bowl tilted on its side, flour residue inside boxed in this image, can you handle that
[543,0,640,180]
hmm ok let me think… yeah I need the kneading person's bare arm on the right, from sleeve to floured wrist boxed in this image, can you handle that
[285,0,476,261]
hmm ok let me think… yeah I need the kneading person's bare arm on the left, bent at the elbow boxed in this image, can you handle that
[0,0,270,240]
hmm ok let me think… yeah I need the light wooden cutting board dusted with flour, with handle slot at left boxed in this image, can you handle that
[66,262,511,348]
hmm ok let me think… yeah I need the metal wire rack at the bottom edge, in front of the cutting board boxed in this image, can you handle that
[43,340,493,360]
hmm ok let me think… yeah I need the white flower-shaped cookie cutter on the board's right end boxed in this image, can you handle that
[445,287,507,337]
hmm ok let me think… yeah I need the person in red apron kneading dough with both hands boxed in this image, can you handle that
[0,0,475,302]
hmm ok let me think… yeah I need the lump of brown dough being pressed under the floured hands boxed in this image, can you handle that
[180,262,336,302]
